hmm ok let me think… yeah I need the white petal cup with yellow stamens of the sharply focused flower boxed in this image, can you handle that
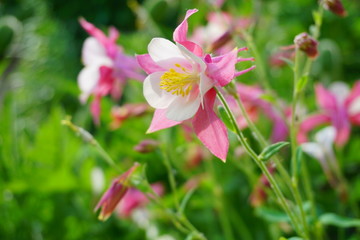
[144,38,214,122]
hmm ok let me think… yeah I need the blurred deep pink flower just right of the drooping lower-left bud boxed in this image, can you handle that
[117,183,164,218]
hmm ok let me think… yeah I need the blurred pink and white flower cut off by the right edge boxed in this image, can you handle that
[297,81,360,146]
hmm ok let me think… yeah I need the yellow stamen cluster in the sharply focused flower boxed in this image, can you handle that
[160,64,199,97]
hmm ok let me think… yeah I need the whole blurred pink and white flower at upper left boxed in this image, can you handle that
[78,19,144,124]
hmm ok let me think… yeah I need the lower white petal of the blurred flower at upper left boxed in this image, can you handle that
[78,66,100,95]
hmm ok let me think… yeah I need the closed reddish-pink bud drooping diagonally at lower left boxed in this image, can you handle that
[95,163,139,221]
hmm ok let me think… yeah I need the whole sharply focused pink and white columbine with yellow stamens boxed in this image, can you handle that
[137,9,254,161]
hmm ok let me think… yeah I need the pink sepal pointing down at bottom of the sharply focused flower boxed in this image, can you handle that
[192,89,229,162]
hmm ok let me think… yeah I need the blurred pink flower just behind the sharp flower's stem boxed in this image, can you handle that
[228,83,288,142]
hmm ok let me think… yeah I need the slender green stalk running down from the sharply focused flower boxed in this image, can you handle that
[215,88,308,239]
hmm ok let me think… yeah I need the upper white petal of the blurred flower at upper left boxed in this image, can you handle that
[82,37,112,66]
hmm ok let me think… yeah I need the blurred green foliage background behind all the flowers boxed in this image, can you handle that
[0,0,360,240]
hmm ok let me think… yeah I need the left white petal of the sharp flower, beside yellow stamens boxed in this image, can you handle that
[143,72,178,109]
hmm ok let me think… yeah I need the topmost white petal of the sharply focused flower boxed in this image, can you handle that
[148,38,185,66]
